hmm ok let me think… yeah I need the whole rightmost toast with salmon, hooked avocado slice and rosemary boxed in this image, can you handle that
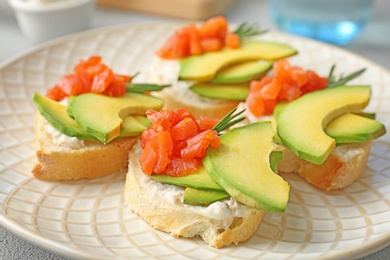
[240,60,386,191]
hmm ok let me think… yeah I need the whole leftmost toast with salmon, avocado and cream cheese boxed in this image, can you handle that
[32,56,163,181]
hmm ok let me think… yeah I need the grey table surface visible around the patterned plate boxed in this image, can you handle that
[0,0,390,260]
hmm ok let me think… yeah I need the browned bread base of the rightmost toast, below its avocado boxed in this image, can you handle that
[278,141,371,191]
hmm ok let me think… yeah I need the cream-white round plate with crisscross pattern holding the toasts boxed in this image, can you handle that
[0,24,390,259]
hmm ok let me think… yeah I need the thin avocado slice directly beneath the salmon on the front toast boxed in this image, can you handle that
[150,166,224,191]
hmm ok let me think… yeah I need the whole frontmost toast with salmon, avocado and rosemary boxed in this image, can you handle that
[124,108,290,248]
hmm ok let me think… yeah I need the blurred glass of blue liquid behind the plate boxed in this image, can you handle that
[269,0,375,45]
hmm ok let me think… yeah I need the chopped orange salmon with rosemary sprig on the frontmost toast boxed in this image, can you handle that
[140,108,244,176]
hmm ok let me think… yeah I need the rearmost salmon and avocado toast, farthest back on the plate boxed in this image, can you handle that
[147,16,297,119]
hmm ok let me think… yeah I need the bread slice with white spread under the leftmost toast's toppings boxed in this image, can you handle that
[32,113,139,181]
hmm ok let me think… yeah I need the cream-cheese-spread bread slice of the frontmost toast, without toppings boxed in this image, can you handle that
[124,142,265,248]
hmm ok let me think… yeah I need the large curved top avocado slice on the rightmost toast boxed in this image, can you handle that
[276,85,371,164]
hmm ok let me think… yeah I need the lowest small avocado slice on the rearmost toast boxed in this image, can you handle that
[190,83,249,101]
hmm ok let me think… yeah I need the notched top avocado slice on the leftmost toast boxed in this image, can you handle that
[67,93,163,143]
